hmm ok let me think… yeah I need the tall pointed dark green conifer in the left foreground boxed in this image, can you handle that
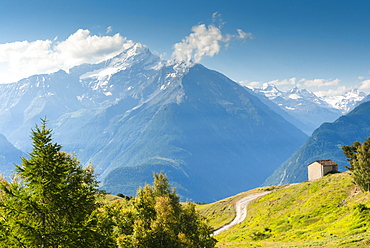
[0,120,98,248]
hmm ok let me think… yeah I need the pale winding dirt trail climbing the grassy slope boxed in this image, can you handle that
[212,191,272,236]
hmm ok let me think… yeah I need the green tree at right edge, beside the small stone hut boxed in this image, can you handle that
[342,137,370,191]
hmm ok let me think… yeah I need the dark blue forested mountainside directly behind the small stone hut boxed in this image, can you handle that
[264,102,370,185]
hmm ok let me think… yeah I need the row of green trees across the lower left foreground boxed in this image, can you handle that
[0,119,216,248]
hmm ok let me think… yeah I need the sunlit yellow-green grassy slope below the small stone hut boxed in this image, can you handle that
[199,173,370,247]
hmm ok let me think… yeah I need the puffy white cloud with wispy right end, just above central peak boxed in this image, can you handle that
[172,22,253,64]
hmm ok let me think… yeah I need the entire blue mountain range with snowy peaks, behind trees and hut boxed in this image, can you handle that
[0,40,370,202]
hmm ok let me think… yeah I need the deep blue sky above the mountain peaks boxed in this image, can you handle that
[0,0,370,94]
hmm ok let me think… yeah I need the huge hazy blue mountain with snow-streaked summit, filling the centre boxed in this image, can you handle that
[0,44,307,202]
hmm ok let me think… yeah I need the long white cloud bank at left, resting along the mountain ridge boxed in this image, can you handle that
[0,29,132,83]
